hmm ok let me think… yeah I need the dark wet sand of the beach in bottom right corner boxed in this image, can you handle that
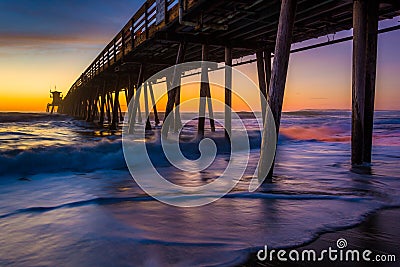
[238,206,400,267]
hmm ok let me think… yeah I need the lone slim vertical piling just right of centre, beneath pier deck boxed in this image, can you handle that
[225,46,232,138]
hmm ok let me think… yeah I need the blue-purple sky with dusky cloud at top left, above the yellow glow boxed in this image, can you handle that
[0,0,142,48]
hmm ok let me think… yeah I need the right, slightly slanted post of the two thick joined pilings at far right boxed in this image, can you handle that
[363,0,379,163]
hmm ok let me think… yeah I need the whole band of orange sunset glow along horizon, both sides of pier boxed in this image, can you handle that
[0,28,400,112]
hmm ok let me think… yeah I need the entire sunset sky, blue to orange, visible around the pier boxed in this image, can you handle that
[0,0,400,111]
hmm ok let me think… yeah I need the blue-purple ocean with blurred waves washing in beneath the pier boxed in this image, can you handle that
[0,110,400,266]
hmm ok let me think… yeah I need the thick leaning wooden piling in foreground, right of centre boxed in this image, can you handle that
[258,0,297,179]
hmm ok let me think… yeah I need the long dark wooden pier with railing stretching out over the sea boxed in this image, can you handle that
[61,0,400,175]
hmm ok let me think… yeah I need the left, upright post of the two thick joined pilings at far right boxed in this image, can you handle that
[351,0,367,165]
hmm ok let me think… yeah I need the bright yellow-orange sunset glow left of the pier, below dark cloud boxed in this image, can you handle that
[0,43,98,112]
